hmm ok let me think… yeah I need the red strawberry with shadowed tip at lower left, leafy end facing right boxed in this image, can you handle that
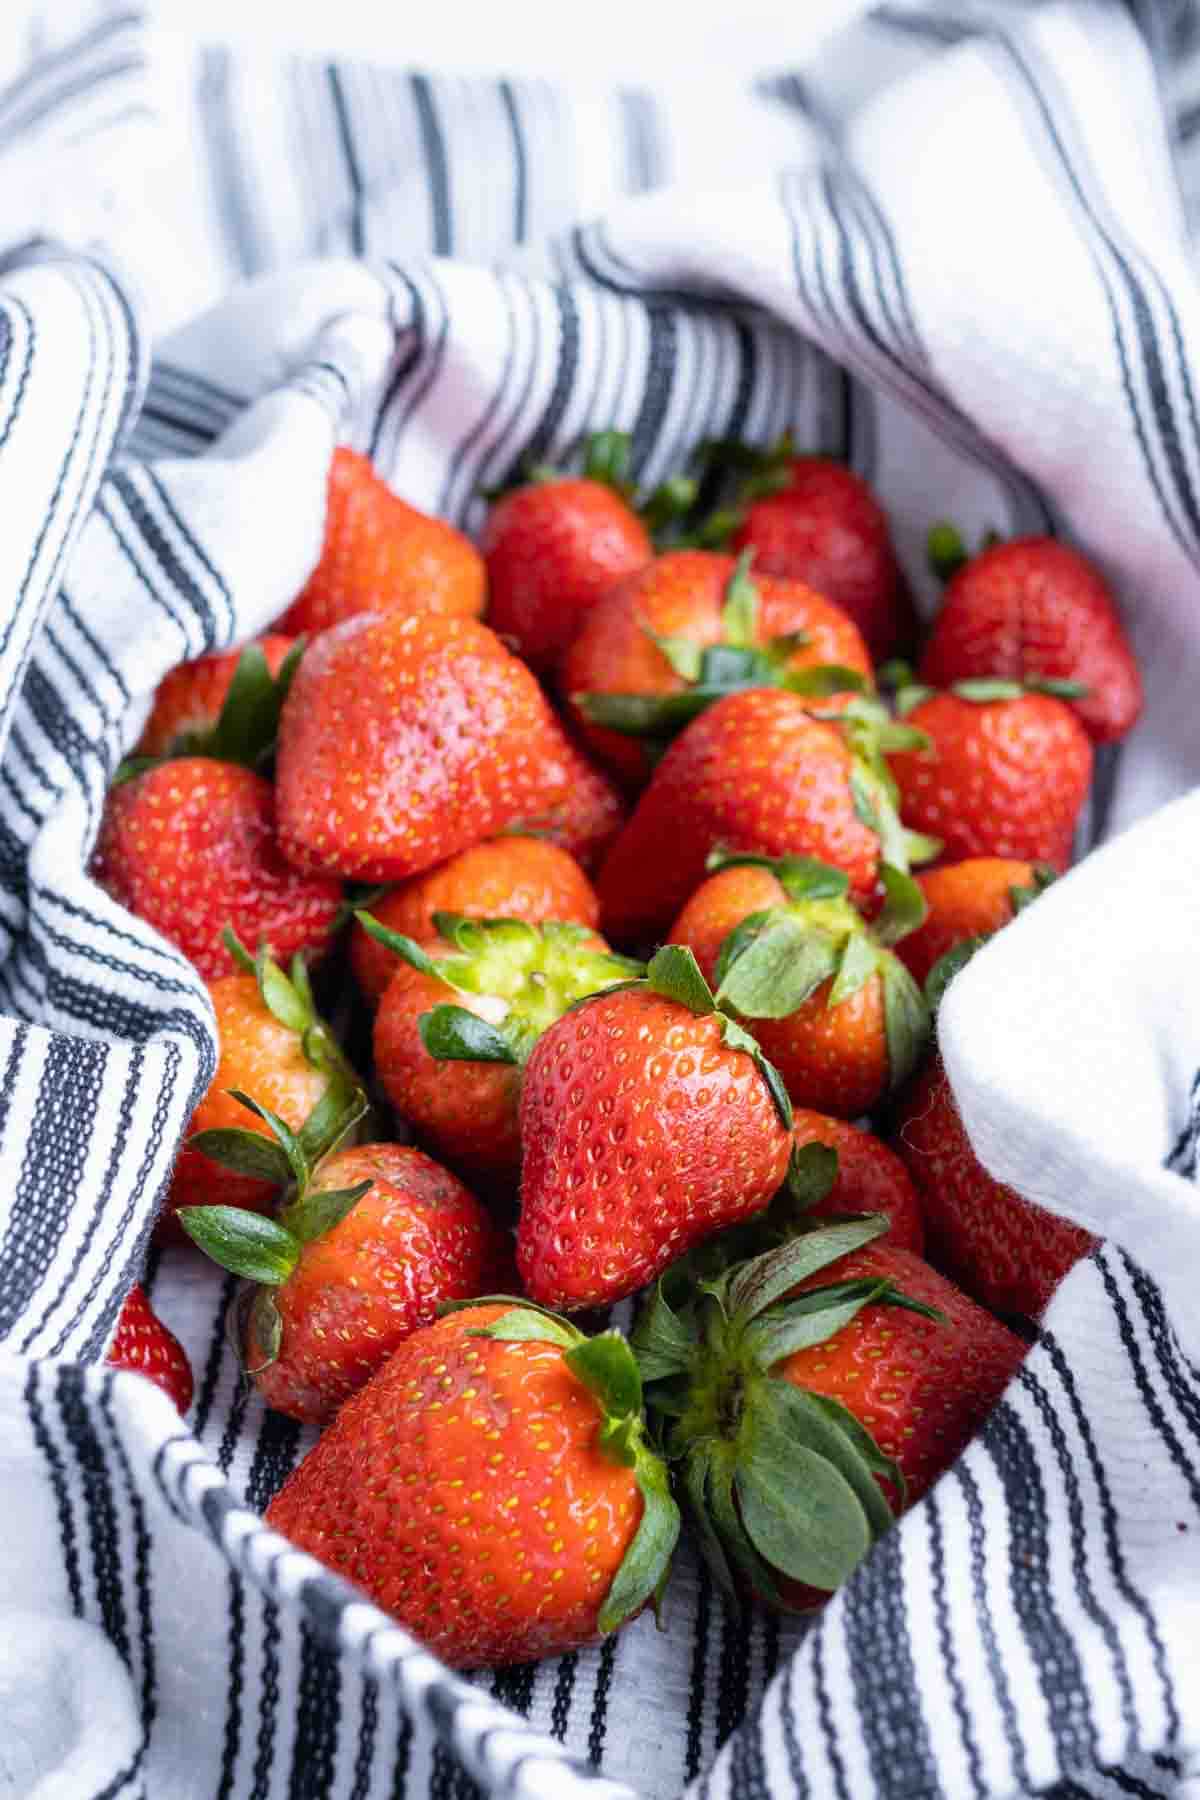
[597,688,937,941]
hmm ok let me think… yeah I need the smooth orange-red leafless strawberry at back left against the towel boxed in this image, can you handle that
[277,448,486,635]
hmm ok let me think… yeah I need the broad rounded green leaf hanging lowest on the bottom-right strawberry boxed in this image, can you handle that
[736,1444,871,1589]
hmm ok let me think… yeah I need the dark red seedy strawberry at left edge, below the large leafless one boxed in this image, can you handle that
[92,756,342,981]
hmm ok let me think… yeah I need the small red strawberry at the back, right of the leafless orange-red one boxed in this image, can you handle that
[480,432,655,673]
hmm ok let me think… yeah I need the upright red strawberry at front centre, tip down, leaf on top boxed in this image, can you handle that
[516,947,792,1310]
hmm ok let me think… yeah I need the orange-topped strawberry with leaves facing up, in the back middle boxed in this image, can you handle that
[560,551,871,787]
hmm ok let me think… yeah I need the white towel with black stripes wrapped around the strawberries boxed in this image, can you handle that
[0,0,1200,1800]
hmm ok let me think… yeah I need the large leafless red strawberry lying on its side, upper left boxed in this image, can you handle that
[275,612,570,882]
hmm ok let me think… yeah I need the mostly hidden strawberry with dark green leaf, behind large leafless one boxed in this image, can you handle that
[122,634,304,774]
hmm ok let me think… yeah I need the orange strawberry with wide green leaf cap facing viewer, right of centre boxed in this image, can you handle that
[671,851,928,1118]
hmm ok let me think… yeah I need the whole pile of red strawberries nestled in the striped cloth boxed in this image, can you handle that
[94,432,1141,1667]
